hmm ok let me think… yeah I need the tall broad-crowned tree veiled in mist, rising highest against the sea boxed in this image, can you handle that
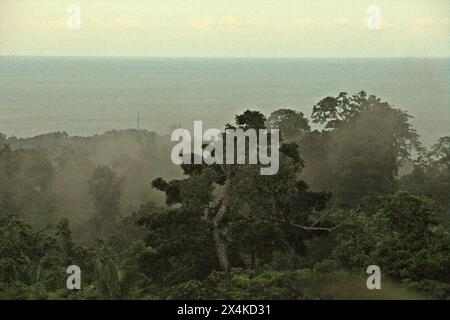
[303,91,419,204]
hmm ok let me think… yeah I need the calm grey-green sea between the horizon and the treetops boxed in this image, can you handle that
[0,56,450,146]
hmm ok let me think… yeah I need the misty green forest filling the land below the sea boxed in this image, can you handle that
[0,92,450,299]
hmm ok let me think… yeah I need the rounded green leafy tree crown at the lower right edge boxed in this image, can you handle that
[334,192,450,298]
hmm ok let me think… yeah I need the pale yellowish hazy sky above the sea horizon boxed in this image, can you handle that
[0,0,450,57]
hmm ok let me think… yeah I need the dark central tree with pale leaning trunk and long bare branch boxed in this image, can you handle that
[151,110,333,278]
